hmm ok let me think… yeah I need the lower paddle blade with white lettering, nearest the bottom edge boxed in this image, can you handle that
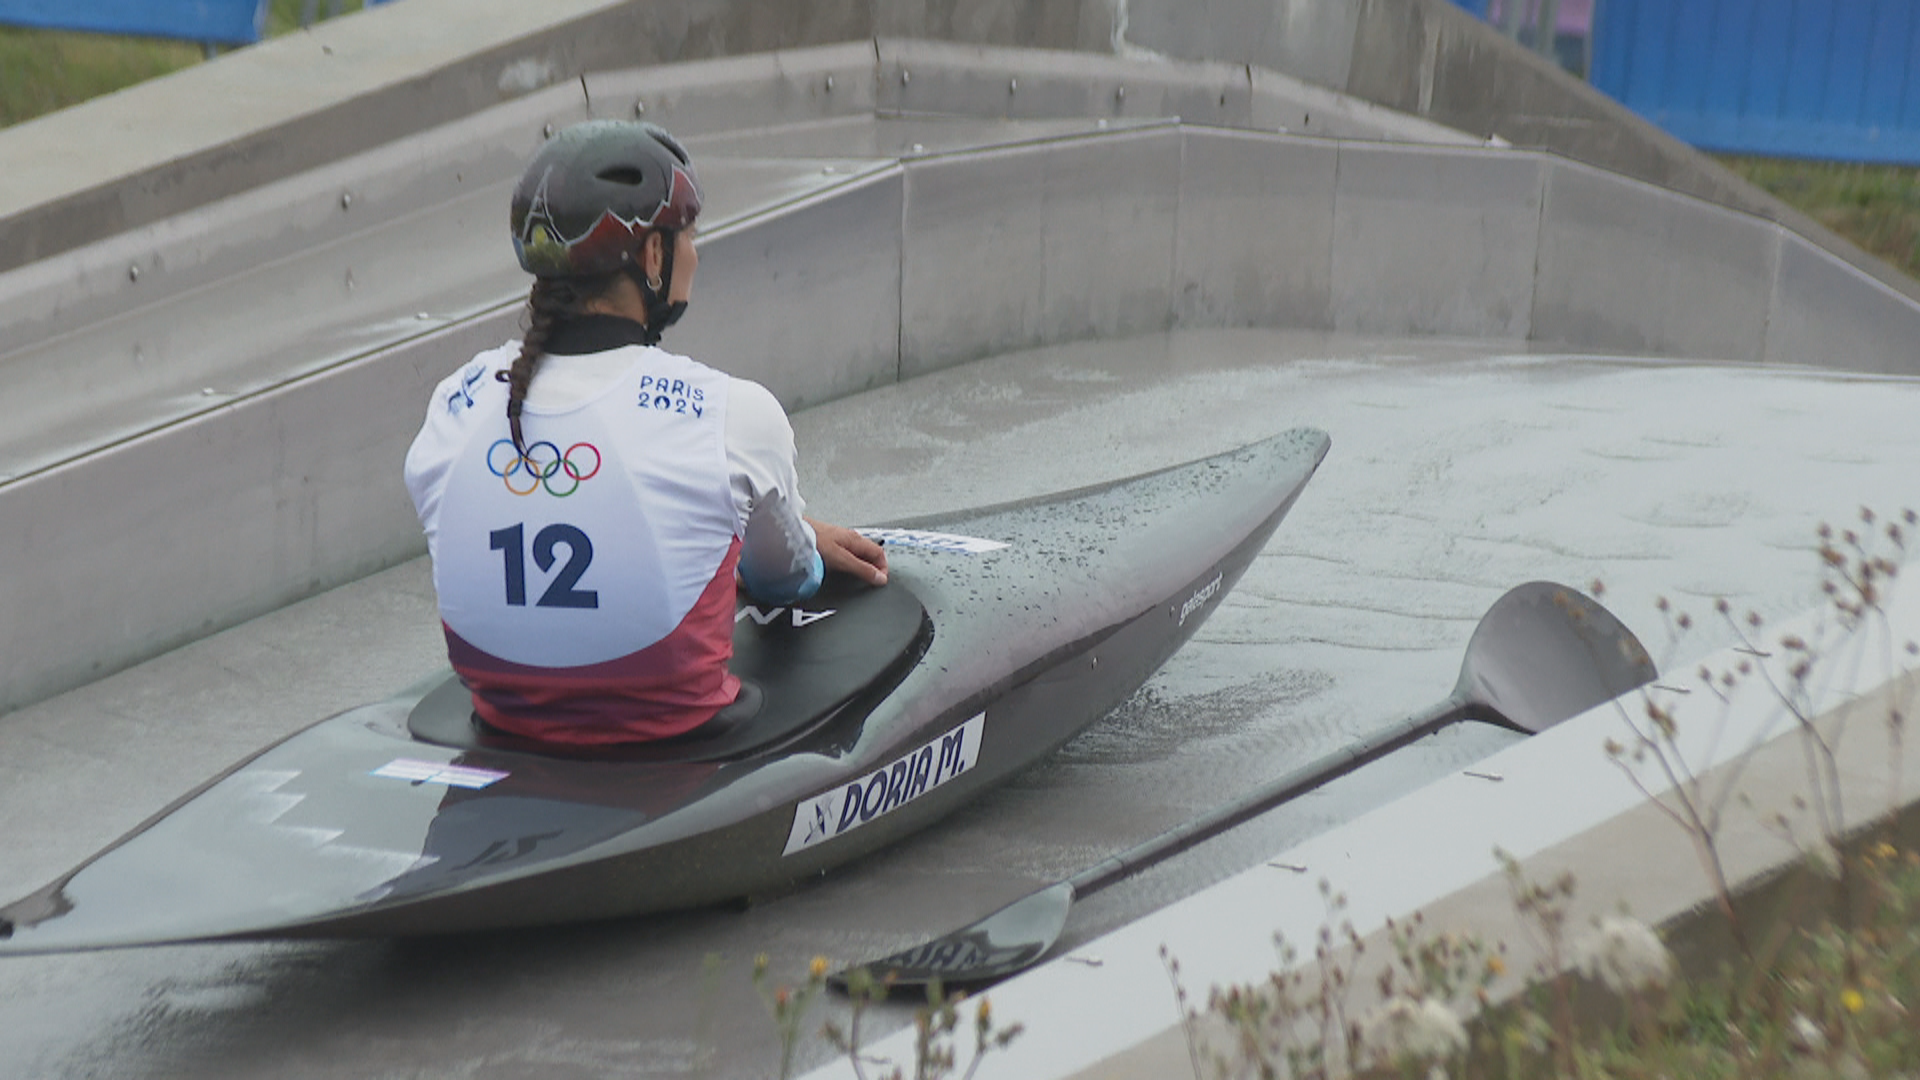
[828,882,1073,990]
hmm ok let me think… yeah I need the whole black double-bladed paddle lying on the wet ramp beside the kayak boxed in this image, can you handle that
[831,580,1657,990]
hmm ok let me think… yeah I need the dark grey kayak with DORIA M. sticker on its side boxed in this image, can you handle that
[0,429,1329,955]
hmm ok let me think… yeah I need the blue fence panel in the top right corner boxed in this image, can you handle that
[1594,0,1920,163]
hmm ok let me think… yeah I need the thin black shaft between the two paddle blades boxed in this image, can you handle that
[1068,698,1475,897]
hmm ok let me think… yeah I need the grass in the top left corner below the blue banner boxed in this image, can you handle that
[0,0,363,127]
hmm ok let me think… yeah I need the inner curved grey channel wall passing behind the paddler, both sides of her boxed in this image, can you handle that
[0,115,1920,709]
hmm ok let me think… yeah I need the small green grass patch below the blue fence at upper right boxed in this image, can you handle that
[1720,158,1920,277]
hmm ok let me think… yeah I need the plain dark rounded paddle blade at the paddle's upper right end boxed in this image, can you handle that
[1453,580,1659,734]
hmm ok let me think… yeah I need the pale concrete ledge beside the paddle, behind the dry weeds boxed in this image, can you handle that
[808,592,1920,1080]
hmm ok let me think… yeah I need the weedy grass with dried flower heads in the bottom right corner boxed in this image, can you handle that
[1171,840,1920,1080]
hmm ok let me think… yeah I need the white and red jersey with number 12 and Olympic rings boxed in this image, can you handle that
[407,344,820,742]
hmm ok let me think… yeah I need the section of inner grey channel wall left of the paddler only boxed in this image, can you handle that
[0,315,516,711]
